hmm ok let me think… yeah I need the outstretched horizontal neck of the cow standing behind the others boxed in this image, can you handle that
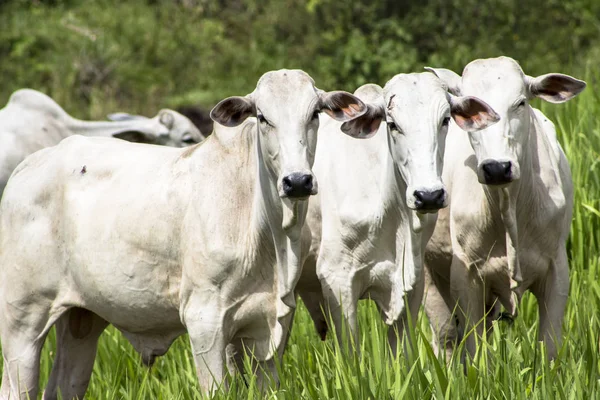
[65,117,160,137]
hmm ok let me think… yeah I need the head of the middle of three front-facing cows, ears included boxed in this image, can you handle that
[342,73,498,213]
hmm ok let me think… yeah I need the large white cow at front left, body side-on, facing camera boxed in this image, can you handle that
[0,70,366,400]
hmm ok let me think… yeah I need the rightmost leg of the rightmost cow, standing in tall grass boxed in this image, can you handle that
[534,249,569,360]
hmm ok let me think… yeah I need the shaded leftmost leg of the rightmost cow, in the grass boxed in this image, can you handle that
[423,268,459,363]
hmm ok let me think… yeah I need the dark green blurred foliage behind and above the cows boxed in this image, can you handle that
[0,0,600,118]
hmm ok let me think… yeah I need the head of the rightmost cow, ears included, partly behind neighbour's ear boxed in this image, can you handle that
[430,57,585,187]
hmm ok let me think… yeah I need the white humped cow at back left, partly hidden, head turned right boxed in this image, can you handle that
[0,89,204,195]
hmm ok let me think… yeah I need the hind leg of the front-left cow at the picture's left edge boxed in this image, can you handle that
[0,321,46,400]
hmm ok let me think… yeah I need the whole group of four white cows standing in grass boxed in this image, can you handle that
[0,57,586,400]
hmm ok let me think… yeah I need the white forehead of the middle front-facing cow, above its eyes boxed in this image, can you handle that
[384,72,449,112]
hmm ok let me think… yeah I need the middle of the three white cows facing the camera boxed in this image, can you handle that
[297,72,497,351]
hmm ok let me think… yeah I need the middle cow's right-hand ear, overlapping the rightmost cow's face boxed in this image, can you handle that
[450,95,500,132]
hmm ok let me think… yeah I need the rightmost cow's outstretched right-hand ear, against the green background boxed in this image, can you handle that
[525,74,586,103]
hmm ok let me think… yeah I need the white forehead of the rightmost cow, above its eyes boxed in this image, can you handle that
[462,57,526,102]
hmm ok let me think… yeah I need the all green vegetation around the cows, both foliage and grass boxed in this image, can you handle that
[0,0,600,400]
